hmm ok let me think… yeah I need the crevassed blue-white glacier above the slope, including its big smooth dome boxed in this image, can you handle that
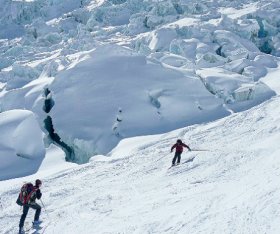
[0,0,280,163]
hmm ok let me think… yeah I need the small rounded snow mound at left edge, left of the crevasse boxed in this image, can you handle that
[0,110,45,180]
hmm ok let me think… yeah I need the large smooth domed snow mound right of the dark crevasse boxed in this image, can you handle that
[49,45,228,161]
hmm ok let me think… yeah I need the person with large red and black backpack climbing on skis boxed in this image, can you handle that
[16,179,42,234]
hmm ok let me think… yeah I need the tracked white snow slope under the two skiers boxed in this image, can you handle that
[0,93,280,234]
